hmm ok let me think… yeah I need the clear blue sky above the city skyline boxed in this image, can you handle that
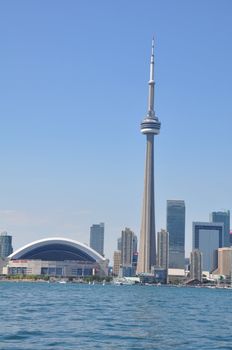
[0,0,232,257]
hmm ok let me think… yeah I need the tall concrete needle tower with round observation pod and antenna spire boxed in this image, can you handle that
[137,39,161,273]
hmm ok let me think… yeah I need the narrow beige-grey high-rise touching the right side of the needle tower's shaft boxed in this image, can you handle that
[157,230,169,270]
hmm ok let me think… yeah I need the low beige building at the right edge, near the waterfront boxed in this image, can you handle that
[213,247,232,277]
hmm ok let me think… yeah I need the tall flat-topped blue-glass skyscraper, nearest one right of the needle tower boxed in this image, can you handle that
[167,200,185,269]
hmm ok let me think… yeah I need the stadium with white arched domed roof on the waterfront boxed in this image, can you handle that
[6,237,108,277]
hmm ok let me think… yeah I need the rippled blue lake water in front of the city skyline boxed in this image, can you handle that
[0,282,232,350]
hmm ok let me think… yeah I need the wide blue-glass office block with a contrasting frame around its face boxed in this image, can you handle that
[192,222,224,272]
